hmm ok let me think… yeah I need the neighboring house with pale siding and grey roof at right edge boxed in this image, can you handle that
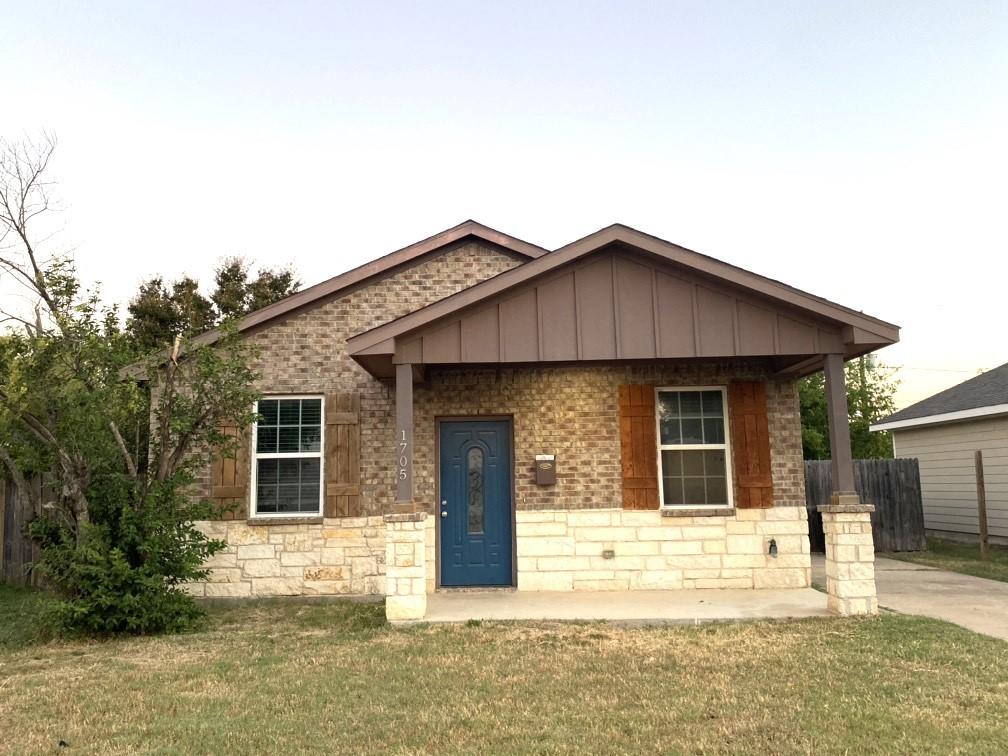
[872,364,1008,543]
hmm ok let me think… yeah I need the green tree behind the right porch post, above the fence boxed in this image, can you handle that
[798,355,899,460]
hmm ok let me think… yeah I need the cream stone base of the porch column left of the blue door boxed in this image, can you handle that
[385,512,427,622]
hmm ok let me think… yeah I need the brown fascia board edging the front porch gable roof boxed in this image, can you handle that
[347,224,899,355]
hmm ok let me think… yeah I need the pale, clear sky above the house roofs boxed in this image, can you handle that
[0,0,1008,406]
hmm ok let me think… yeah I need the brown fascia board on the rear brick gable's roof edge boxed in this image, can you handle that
[120,220,548,377]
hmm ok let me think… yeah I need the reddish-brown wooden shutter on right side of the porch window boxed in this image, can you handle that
[728,382,773,508]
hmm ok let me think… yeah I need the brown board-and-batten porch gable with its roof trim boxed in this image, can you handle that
[348,226,899,378]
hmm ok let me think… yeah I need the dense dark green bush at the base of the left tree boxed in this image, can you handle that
[30,479,224,635]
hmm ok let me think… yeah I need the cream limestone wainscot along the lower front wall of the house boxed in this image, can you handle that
[190,507,811,597]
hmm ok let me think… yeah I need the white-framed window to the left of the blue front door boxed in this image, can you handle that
[252,396,325,517]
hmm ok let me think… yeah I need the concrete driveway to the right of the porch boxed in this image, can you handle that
[812,553,1008,640]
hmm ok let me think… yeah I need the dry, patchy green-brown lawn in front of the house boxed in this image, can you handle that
[0,591,1008,754]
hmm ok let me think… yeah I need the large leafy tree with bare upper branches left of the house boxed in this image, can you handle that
[0,137,256,633]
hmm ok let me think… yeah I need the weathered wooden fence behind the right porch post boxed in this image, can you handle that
[805,460,926,551]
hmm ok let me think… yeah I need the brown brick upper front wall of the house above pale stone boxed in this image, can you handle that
[201,243,804,515]
